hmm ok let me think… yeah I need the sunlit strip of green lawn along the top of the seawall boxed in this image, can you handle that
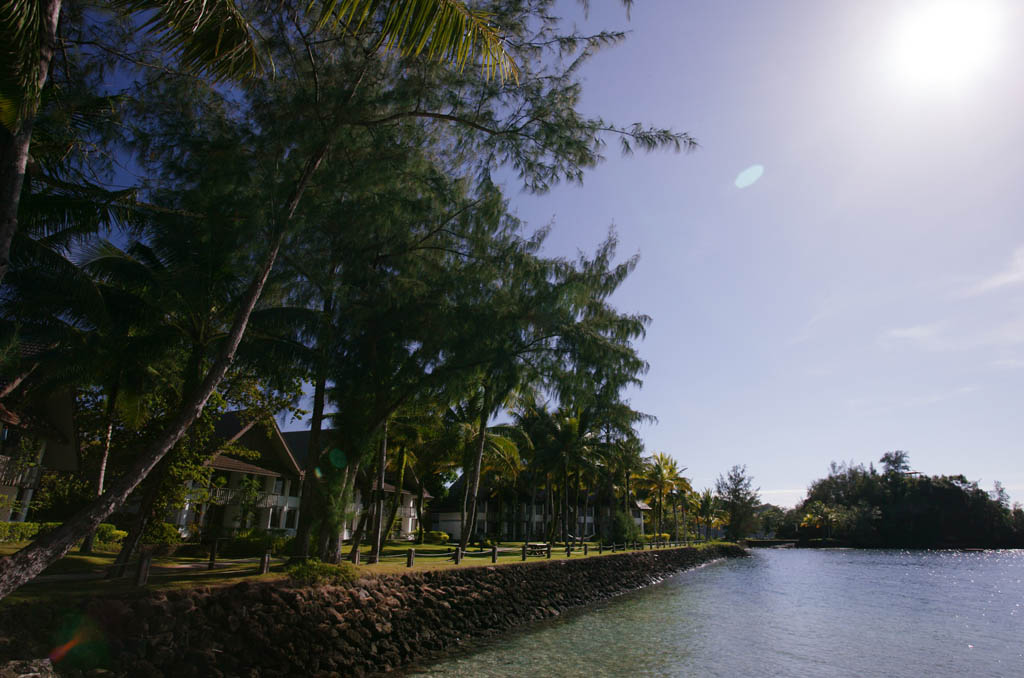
[0,542,737,605]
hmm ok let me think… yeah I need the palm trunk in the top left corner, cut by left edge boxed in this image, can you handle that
[0,0,60,285]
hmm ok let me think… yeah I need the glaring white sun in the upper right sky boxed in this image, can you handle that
[887,0,999,91]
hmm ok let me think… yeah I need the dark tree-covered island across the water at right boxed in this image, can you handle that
[758,451,1024,549]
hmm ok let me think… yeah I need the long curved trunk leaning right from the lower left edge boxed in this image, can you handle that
[0,232,284,600]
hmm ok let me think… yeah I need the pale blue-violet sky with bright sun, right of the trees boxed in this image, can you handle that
[489,0,1024,506]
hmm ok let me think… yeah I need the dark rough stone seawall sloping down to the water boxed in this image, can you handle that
[0,546,746,678]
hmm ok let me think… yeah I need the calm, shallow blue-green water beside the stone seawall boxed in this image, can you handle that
[409,549,1024,678]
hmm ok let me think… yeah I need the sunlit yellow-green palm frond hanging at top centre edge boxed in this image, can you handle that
[310,0,519,82]
